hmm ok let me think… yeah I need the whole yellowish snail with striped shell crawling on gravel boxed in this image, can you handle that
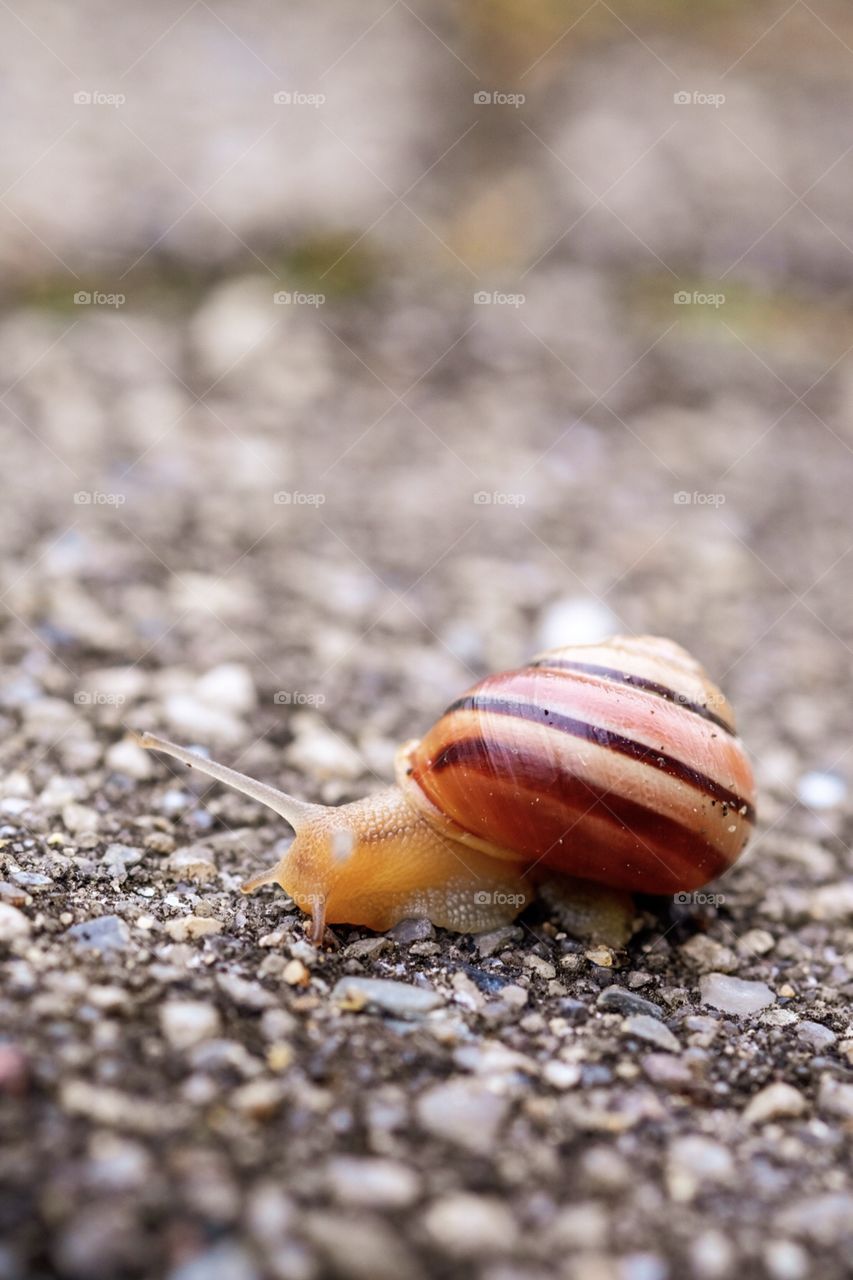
[138,636,754,942]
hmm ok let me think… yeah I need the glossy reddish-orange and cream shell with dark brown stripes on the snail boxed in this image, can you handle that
[398,636,754,893]
